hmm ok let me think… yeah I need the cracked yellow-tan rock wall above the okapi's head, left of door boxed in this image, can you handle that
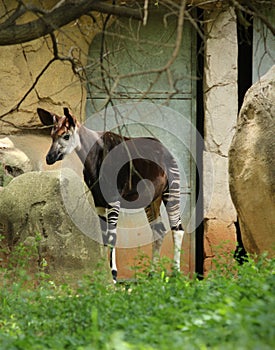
[0,1,99,135]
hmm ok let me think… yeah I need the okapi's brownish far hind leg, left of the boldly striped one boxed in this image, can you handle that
[145,197,166,266]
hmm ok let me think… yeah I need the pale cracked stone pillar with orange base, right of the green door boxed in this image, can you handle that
[203,8,238,272]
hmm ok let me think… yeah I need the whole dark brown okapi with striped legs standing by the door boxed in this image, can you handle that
[37,108,184,282]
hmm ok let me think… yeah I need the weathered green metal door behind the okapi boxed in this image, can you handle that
[86,10,196,275]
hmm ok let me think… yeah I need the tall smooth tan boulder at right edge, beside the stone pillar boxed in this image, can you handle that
[229,65,275,256]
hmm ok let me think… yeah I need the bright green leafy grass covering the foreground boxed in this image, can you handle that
[0,253,275,350]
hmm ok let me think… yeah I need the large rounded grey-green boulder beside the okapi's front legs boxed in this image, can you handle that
[0,169,110,283]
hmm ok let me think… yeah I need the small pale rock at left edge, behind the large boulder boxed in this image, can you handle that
[0,137,32,186]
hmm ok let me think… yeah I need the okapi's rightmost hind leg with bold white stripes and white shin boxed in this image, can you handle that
[162,161,184,271]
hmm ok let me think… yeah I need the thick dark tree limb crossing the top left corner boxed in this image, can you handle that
[0,0,143,46]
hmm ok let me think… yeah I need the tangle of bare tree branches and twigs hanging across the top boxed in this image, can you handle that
[0,0,275,133]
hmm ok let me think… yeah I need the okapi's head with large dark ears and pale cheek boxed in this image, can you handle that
[37,108,81,164]
